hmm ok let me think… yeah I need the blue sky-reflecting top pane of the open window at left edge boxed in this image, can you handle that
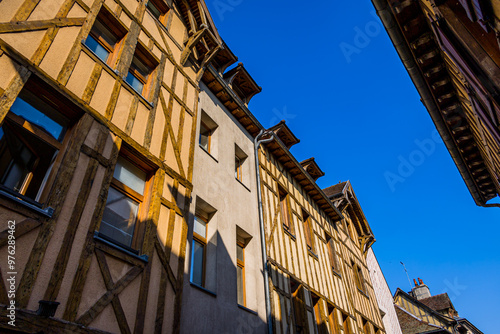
[10,94,64,141]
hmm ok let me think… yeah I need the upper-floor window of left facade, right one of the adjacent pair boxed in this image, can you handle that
[125,42,158,98]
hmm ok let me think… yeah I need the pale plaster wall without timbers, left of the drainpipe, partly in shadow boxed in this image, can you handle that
[181,84,266,334]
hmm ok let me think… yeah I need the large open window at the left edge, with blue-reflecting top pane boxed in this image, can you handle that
[0,79,76,206]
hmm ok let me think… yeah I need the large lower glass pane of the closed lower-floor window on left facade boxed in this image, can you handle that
[99,188,139,247]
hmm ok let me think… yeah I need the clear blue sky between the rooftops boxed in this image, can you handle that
[207,0,500,333]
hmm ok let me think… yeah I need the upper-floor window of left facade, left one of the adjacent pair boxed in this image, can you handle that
[85,7,127,67]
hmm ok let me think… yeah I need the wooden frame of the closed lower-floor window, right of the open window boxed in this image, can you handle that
[98,147,154,254]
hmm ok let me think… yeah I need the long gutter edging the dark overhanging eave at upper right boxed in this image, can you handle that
[372,0,486,206]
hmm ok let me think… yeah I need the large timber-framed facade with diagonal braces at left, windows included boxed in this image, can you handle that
[0,0,222,333]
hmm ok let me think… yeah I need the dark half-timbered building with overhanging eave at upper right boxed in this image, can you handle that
[372,0,500,207]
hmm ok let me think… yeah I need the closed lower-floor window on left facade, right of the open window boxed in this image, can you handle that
[99,155,148,250]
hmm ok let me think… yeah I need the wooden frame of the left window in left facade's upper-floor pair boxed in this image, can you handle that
[84,5,128,69]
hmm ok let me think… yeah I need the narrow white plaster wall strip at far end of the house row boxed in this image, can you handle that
[366,248,402,334]
